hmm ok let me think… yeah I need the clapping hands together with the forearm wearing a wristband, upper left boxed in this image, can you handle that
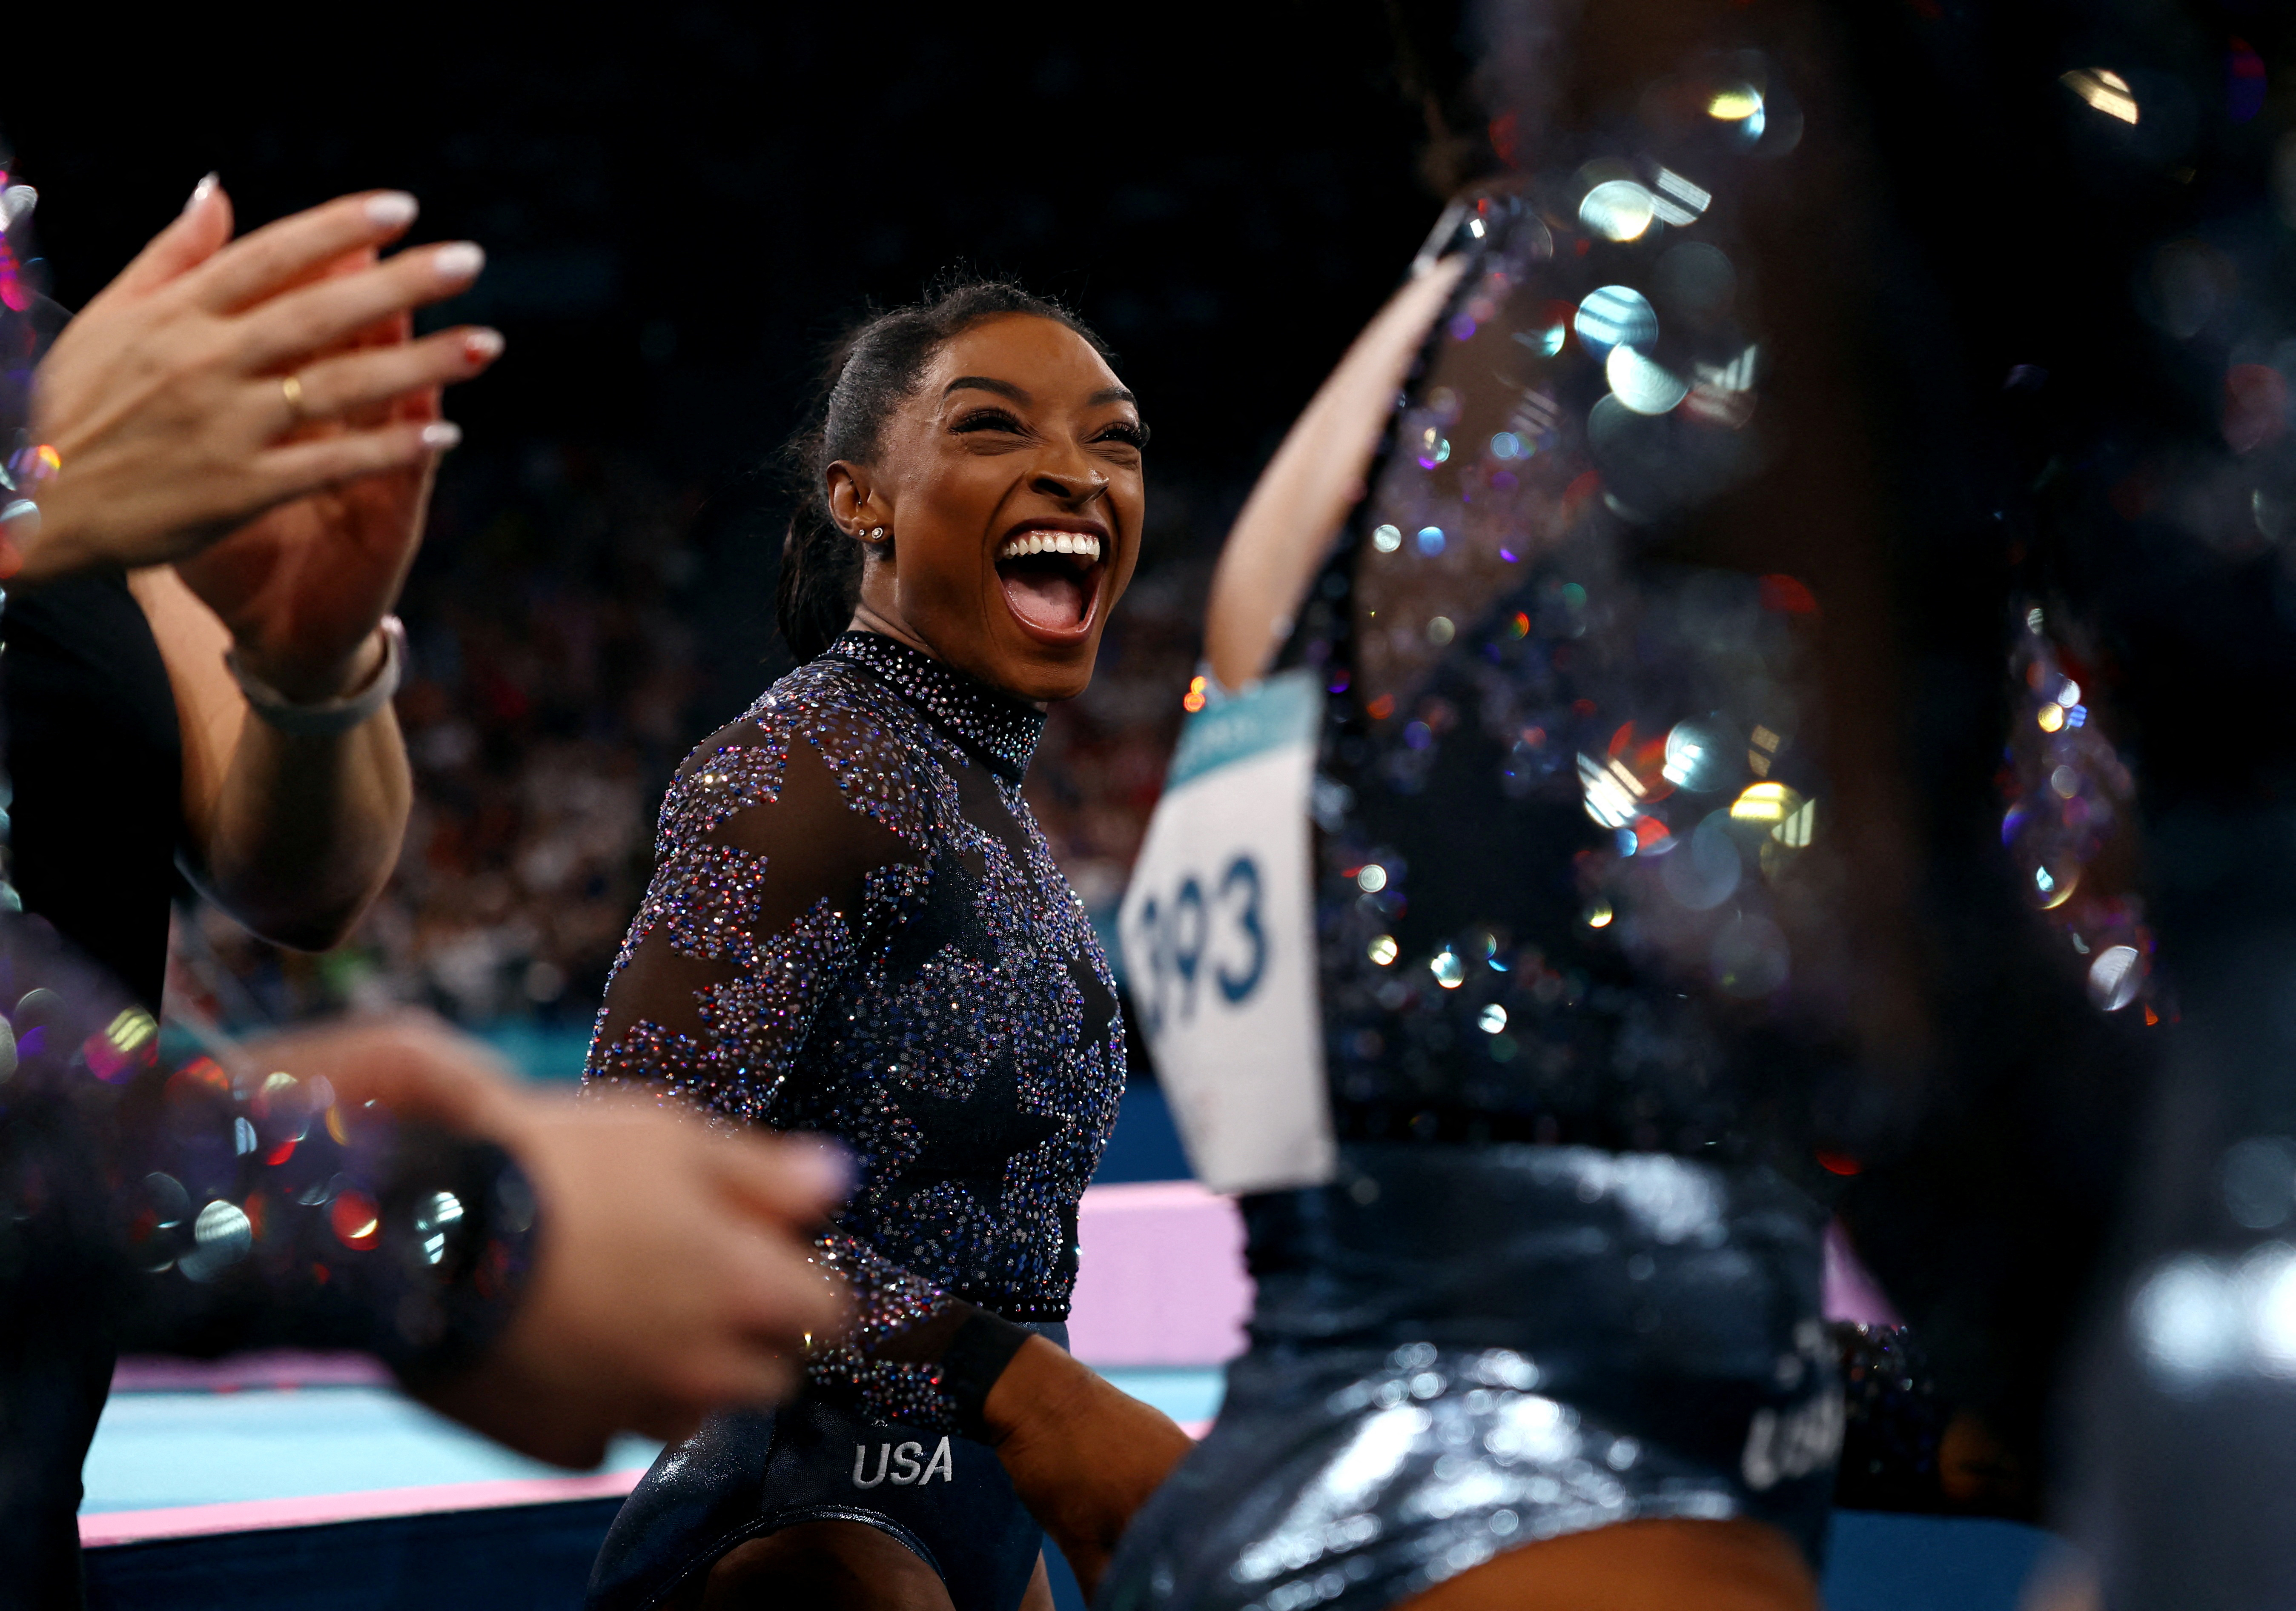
[17,183,503,948]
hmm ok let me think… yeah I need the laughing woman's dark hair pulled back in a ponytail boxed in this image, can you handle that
[774,278,1114,661]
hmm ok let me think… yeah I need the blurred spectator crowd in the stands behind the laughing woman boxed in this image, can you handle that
[168,443,1217,1046]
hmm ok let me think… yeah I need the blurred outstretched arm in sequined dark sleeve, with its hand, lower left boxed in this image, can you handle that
[0,916,843,1464]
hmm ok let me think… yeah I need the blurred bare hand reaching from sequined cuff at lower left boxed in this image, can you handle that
[259,1017,849,1466]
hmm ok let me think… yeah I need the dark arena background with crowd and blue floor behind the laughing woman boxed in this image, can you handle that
[0,0,2041,1611]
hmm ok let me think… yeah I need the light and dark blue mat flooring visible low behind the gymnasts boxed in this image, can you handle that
[83,1370,2048,1611]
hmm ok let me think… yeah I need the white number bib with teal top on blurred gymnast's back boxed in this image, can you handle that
[1118,670,1336,1191]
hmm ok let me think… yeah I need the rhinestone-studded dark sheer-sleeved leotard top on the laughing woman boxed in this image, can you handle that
[585,633,1125,1423]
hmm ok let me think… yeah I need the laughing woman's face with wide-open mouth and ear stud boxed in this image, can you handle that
[829,315,1148,700]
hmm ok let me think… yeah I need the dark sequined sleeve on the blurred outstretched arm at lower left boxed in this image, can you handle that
[0,913,535,1386]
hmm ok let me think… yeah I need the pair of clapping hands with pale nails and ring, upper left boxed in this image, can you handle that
[21,181,501,698]
